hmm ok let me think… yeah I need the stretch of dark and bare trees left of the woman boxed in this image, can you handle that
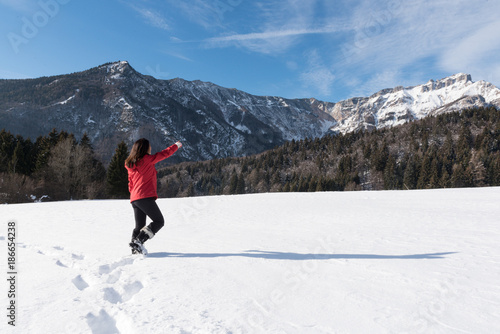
[0,129,128,203]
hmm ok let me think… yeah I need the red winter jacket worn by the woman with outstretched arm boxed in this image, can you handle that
[125,144,178,202]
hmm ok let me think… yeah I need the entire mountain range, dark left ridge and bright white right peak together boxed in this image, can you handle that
[0,61,500,162]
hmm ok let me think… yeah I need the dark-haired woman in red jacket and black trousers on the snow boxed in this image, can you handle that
[125,138,182,254]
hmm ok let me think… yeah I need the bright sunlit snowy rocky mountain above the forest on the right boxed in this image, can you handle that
[328,73,500,133]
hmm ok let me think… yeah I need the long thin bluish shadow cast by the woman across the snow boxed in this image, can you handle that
[148,250,456,260]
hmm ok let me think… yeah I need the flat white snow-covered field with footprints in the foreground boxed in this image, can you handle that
[0,188,500,334]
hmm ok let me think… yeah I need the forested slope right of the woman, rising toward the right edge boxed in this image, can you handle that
[159,107,500,197]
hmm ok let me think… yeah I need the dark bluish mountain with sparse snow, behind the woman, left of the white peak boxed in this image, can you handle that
[0,61,335,161]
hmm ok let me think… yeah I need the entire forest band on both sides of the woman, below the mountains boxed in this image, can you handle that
[0,107,500,203]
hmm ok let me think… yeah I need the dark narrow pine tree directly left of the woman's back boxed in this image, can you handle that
[107,141,129,198]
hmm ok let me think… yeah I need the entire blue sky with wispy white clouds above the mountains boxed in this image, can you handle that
[0,0,500,102]
